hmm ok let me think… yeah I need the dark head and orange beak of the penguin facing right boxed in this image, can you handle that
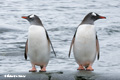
[81,12,106,24]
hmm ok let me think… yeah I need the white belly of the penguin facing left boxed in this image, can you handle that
[28,25,50,66]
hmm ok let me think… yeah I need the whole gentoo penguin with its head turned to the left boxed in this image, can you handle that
[22,14,56,72]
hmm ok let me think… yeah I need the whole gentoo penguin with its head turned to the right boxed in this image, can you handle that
[69,12,106,71]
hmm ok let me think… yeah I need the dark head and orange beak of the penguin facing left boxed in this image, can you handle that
[22,14,42,25]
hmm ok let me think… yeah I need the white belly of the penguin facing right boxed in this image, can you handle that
[73,24,96,65]
